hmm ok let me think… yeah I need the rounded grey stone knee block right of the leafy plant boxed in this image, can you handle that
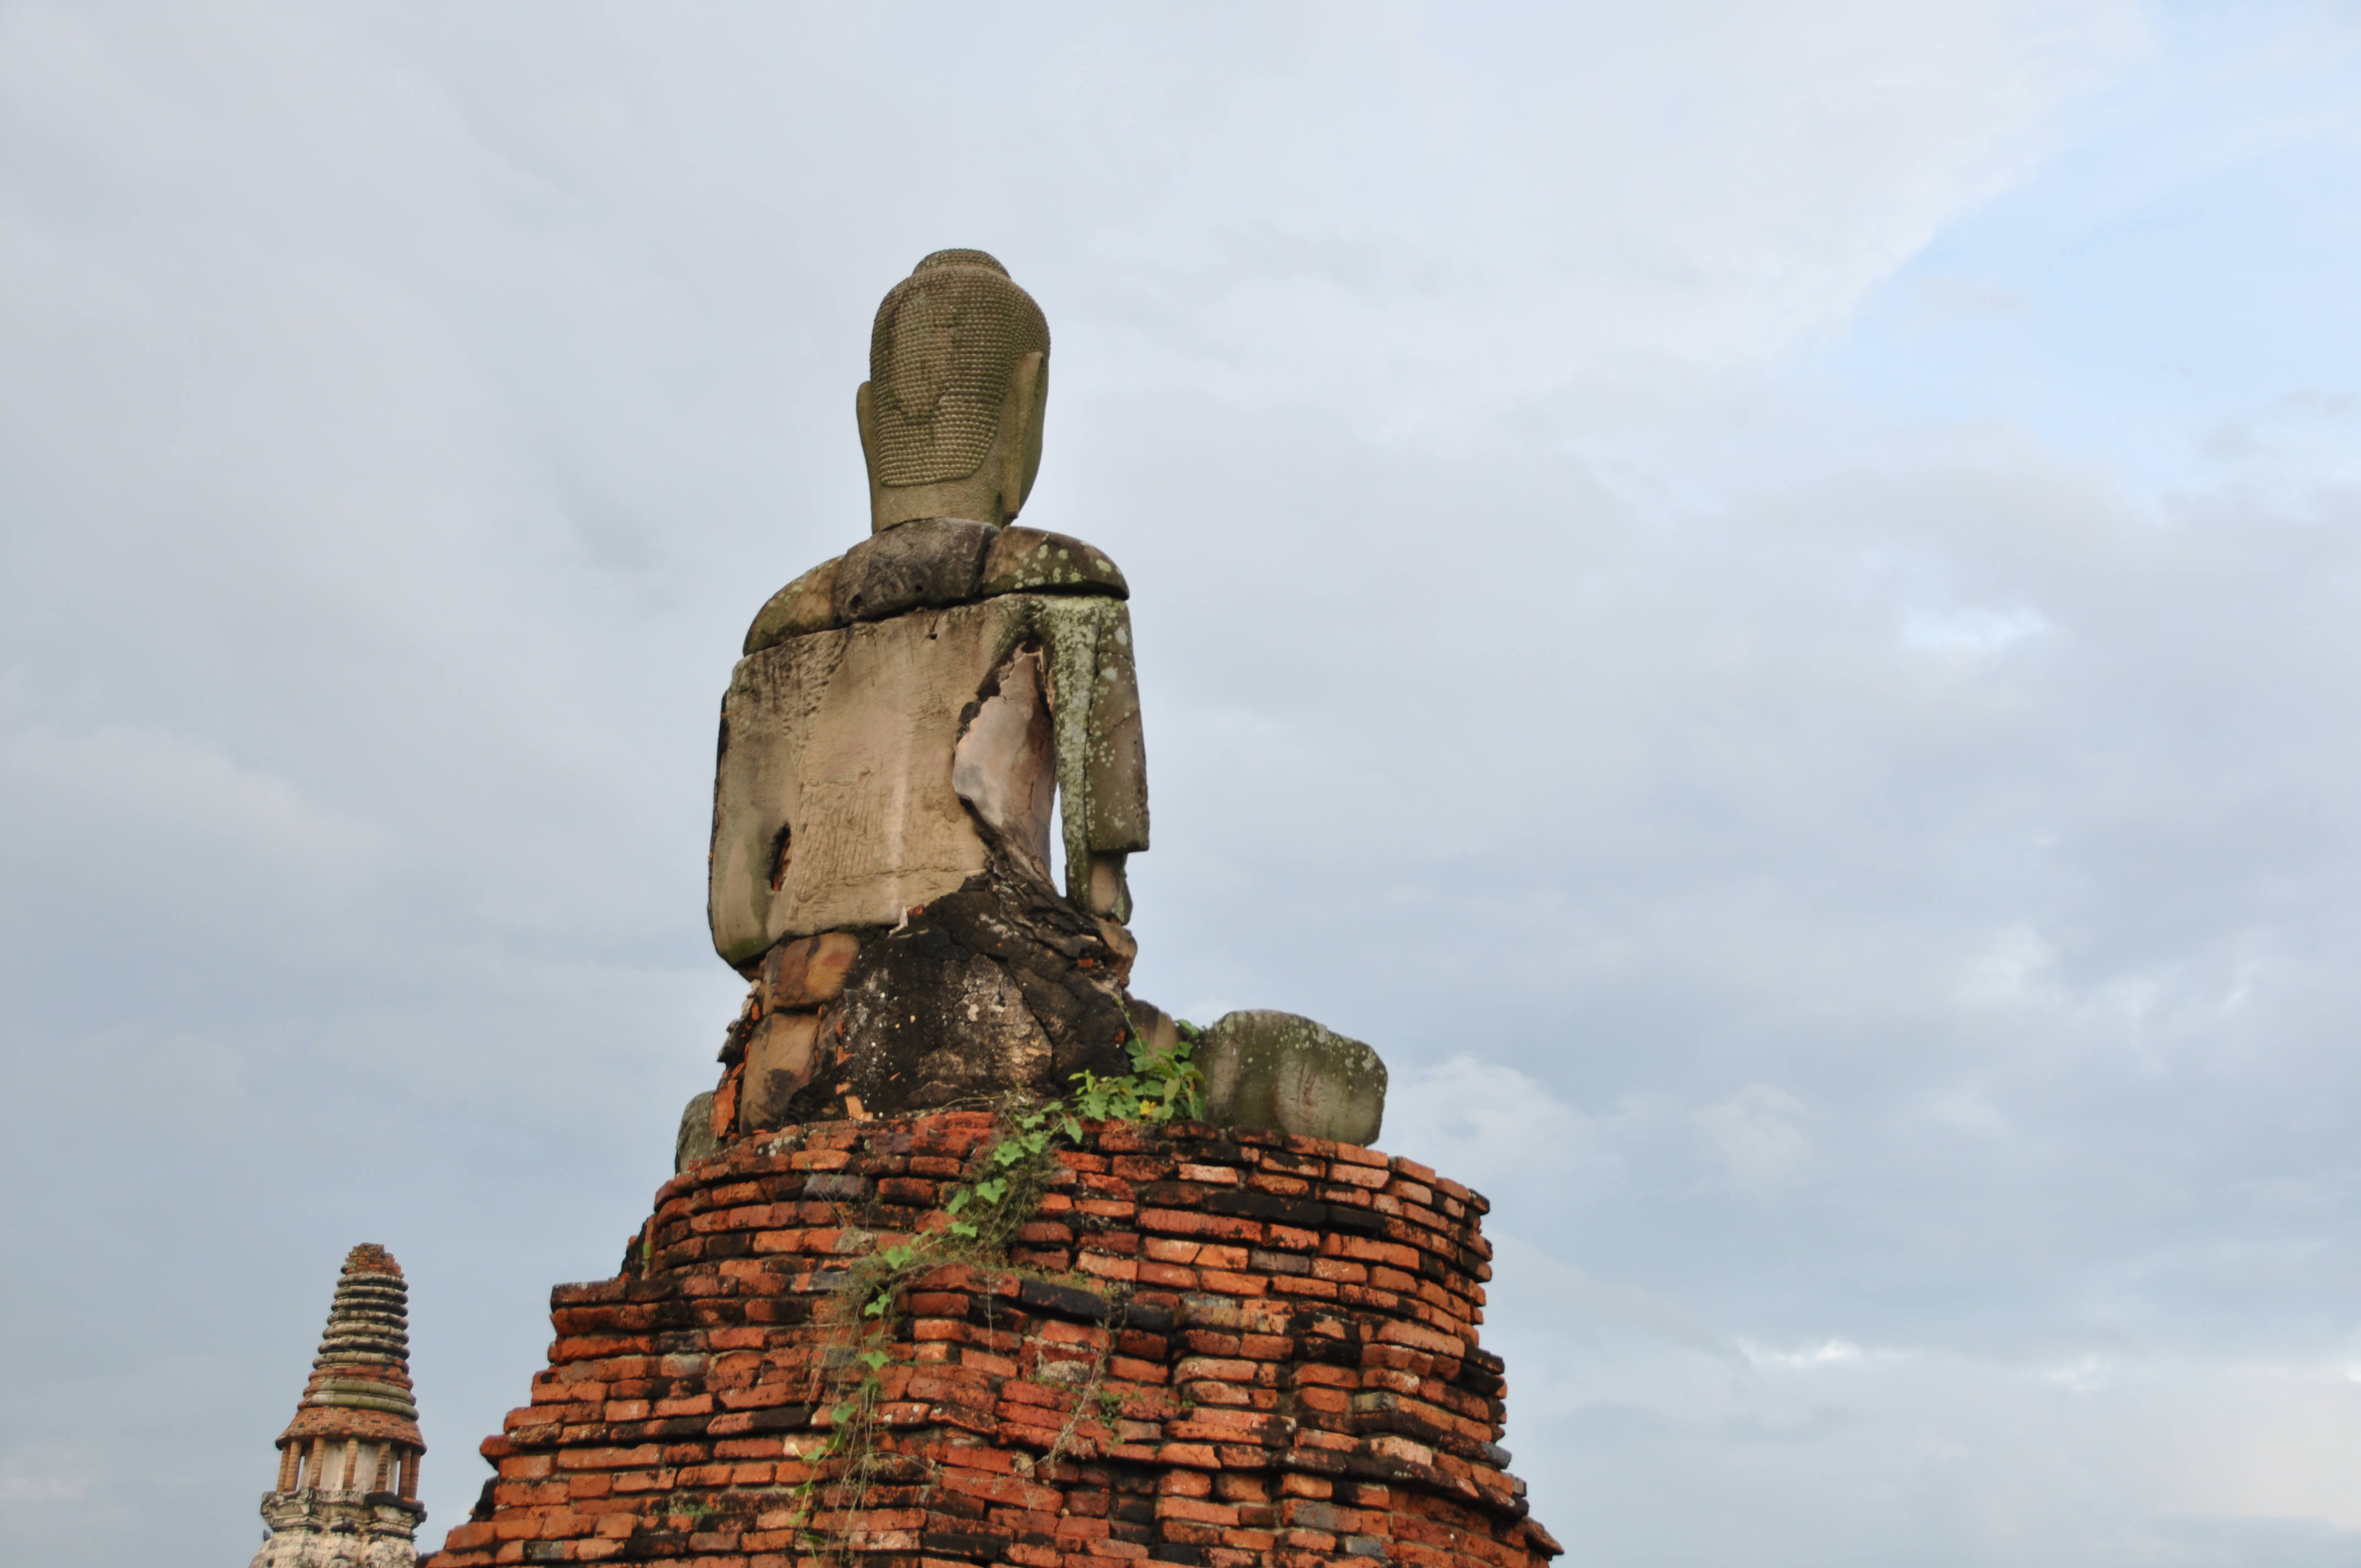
[1195,1011,1386,1145]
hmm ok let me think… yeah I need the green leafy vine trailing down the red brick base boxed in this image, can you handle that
[796,1018,1204,1561]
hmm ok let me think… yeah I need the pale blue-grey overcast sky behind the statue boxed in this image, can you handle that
[0,0,2361,1568]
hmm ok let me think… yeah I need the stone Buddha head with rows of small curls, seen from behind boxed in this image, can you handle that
[855,251,1048,533]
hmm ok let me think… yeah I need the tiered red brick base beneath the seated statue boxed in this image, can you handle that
[429,1112,1558,1568]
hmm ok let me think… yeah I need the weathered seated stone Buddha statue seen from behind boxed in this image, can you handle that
[685,251,1147,1138]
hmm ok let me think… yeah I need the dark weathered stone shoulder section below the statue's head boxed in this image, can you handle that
[744,517,1131,654]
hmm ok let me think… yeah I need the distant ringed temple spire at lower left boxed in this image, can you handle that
[251,1242,427,1568]
